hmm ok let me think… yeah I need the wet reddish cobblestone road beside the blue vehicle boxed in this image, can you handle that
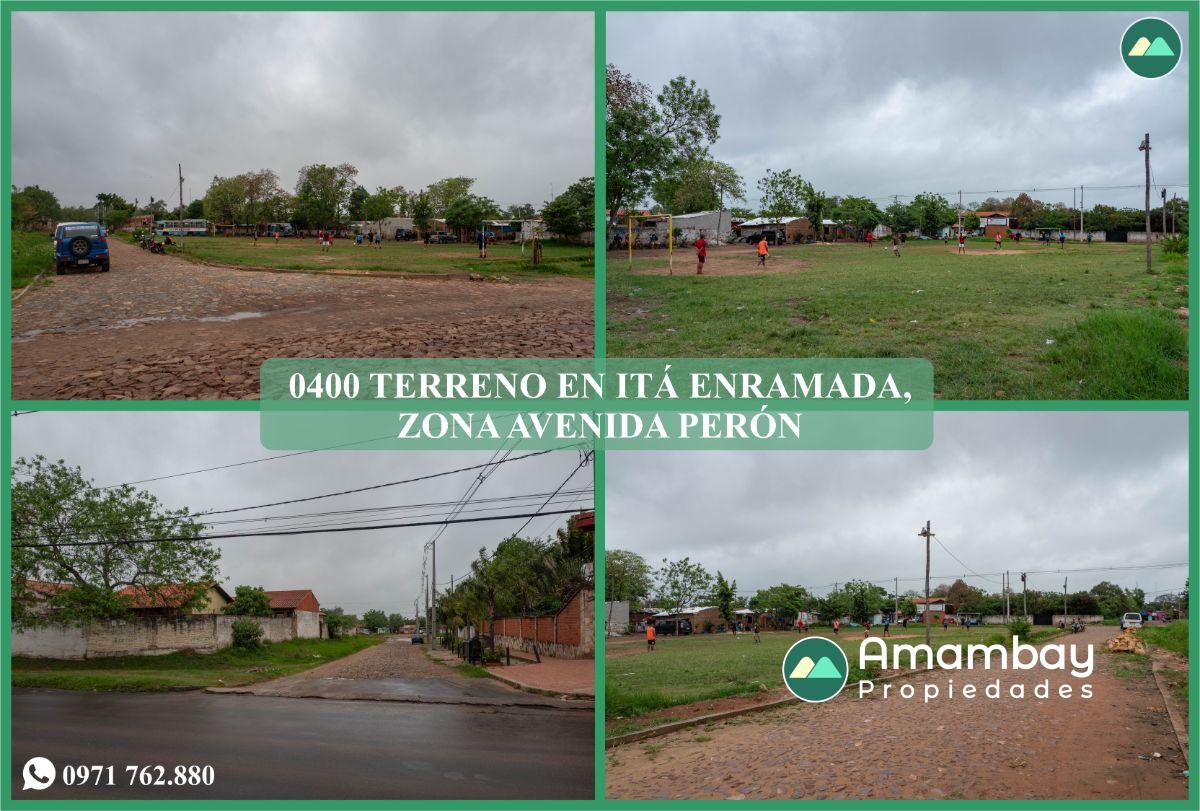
[12,239,593,400]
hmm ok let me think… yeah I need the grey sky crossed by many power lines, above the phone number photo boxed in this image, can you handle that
[12,411,593,615]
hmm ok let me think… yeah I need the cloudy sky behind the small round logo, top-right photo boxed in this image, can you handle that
[607,12,1188,208]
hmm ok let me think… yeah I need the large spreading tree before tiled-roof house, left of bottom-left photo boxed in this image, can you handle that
[11,456,221,626]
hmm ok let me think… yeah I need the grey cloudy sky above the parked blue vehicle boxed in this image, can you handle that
[12,12,594,205]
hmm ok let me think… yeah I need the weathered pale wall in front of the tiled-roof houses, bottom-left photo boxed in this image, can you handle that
[12,611,322,659]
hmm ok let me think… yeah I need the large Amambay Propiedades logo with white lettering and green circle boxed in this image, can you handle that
[784,636,1094,703]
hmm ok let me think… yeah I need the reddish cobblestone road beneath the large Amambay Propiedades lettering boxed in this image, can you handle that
[606,627,1187,800]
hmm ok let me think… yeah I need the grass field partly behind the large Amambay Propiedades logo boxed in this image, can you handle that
[605,626,1057,719]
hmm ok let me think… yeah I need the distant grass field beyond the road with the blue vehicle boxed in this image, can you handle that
[170,236,593,277]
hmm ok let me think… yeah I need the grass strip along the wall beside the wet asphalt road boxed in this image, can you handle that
[12,636,384,692]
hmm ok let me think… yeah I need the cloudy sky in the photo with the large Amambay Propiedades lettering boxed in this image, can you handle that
[606,411,1188,604]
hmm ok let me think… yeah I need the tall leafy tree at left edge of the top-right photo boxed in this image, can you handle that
[605,65,721,218]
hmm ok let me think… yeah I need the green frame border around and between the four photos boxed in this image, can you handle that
[0,0,1200,811]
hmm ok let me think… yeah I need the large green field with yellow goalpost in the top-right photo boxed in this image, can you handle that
[607,241,1188,400]
